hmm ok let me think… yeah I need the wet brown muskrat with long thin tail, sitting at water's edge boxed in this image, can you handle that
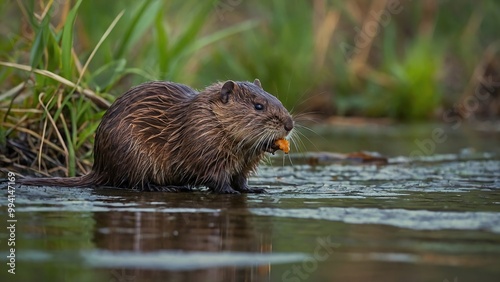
[19,79,294,193]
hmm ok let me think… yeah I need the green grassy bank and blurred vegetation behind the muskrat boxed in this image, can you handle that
[0,0,500,175]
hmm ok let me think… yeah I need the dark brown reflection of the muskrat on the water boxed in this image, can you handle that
[94,193,272,281]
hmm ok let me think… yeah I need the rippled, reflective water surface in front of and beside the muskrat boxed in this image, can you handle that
[0,122,500,282]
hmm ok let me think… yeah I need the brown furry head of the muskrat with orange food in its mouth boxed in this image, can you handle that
[209,79,294,153]
